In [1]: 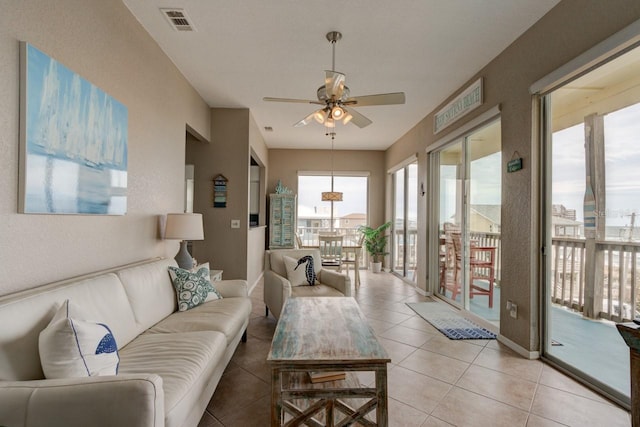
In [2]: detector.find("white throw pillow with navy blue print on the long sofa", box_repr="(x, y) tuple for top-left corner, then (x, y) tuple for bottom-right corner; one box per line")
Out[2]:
(39, 300), (120, 378)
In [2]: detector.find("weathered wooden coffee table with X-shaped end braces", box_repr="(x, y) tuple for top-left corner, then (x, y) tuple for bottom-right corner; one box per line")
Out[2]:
(267, 297), (391, 427)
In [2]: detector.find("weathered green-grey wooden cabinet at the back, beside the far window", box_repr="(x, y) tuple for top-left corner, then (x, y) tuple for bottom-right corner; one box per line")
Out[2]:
(269, 194), (296, 249)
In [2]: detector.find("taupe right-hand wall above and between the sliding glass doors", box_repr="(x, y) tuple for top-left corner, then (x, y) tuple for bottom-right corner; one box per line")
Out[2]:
(386, 0), (640, 351)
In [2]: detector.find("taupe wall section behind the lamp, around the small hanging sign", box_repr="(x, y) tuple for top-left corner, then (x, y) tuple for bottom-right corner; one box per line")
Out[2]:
(187, 108), (268, 285)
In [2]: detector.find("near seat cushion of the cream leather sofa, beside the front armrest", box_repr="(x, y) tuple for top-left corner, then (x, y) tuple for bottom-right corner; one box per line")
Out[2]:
(120, 332), (227, 425)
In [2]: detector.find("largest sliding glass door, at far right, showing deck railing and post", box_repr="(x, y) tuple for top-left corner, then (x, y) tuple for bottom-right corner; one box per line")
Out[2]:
(542, 48), (640, 403)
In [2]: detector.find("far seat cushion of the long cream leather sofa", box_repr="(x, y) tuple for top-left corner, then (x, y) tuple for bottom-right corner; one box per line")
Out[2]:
(147, 298), (251, 343)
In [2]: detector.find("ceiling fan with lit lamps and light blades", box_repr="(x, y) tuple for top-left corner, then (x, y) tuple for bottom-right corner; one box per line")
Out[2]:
(262, 31), (405, 128)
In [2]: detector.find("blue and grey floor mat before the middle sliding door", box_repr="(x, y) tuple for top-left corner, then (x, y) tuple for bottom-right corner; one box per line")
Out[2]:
(406, 302), (496, 340)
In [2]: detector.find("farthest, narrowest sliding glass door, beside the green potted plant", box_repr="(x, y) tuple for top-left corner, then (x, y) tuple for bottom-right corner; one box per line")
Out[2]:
(391, 162), (418, 282)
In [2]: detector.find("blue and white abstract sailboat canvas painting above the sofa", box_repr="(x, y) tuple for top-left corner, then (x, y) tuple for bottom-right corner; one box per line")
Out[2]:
(19, 42), (128, 215)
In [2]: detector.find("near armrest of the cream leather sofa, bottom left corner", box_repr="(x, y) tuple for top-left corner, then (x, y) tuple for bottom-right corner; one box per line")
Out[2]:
(0, 374), (164, 427)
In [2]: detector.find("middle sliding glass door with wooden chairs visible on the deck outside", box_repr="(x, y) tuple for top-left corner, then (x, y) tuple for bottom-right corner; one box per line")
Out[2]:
(430, 120), (502, 326)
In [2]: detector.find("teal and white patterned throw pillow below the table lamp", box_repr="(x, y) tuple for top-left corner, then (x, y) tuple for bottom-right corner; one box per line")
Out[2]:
(169, 267), (222, 311)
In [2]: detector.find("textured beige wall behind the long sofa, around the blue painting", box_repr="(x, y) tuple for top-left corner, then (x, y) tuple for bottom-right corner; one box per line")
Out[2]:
(0, 0), (210, 294)
